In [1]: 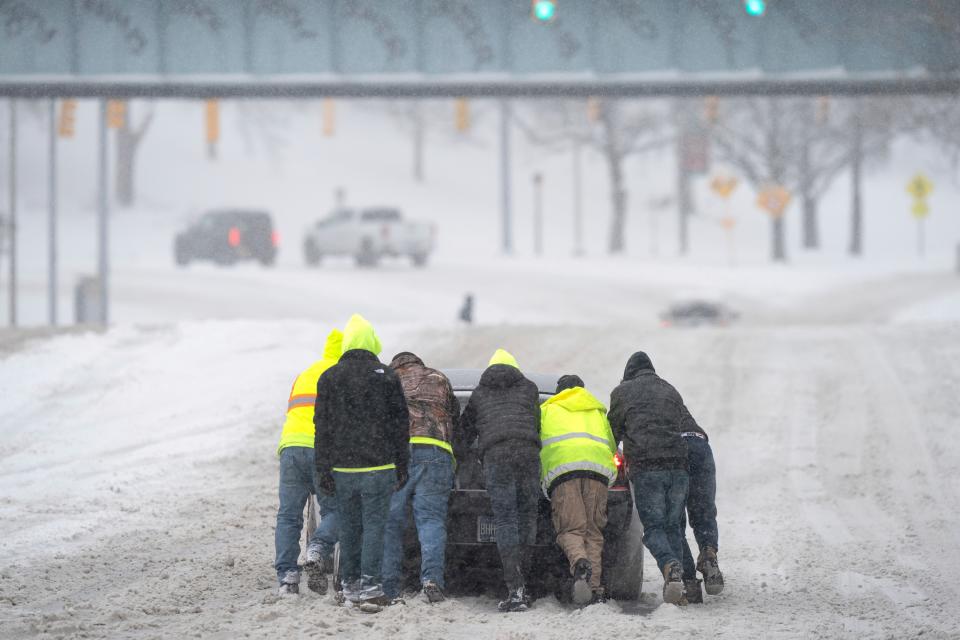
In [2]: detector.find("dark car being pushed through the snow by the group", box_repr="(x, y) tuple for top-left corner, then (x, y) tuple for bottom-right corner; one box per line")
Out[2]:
(382, 369), (643, 600)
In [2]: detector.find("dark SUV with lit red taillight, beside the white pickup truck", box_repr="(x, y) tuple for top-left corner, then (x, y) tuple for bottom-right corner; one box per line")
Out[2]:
(173, 209), (279, 266)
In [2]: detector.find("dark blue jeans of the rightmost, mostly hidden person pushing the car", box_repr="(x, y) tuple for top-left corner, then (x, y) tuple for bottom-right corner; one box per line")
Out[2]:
(683, 436), (720, 580)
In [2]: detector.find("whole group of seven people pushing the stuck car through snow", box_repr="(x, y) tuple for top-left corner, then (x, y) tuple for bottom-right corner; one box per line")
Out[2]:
(275, 315), (723, 612)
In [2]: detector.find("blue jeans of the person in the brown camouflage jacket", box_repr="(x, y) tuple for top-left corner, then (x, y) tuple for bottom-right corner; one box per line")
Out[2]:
(383, 445), (453, 598)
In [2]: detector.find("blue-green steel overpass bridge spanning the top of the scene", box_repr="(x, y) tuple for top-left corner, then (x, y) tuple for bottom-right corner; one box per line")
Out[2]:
(0, 0), (960, 98)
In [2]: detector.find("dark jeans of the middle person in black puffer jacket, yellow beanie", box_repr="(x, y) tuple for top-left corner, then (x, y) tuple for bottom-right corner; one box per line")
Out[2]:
(483, 449), (542, 591)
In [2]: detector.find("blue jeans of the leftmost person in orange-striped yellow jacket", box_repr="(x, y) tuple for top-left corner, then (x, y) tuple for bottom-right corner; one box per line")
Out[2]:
(274, 447), (338, 580)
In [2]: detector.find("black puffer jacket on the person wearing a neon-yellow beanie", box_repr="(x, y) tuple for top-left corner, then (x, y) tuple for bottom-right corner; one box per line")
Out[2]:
(460, 364), (540, 462)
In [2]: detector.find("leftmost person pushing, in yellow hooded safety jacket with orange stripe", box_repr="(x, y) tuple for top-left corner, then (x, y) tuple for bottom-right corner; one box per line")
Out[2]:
(276, 329), (343, 595)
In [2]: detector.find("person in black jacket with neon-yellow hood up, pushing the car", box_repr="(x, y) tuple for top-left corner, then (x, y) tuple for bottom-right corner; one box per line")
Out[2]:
(314, 315), (409, 605)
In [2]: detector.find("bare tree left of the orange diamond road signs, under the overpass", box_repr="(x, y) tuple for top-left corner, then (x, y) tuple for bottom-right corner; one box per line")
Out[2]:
(514, 99), (674, 254)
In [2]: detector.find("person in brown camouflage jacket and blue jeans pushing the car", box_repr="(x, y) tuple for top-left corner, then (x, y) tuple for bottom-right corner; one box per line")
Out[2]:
(383, 351), (460, 602)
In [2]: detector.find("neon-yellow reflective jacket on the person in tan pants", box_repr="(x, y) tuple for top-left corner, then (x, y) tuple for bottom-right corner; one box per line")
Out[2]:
(540, 387), (617, 497)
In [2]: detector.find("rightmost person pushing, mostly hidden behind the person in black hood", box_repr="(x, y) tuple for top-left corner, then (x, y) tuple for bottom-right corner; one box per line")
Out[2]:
(680, 405), (723, 604)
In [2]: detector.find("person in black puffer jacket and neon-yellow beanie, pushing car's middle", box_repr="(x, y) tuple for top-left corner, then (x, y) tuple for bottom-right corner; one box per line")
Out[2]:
(460, 349), (540, 611)
